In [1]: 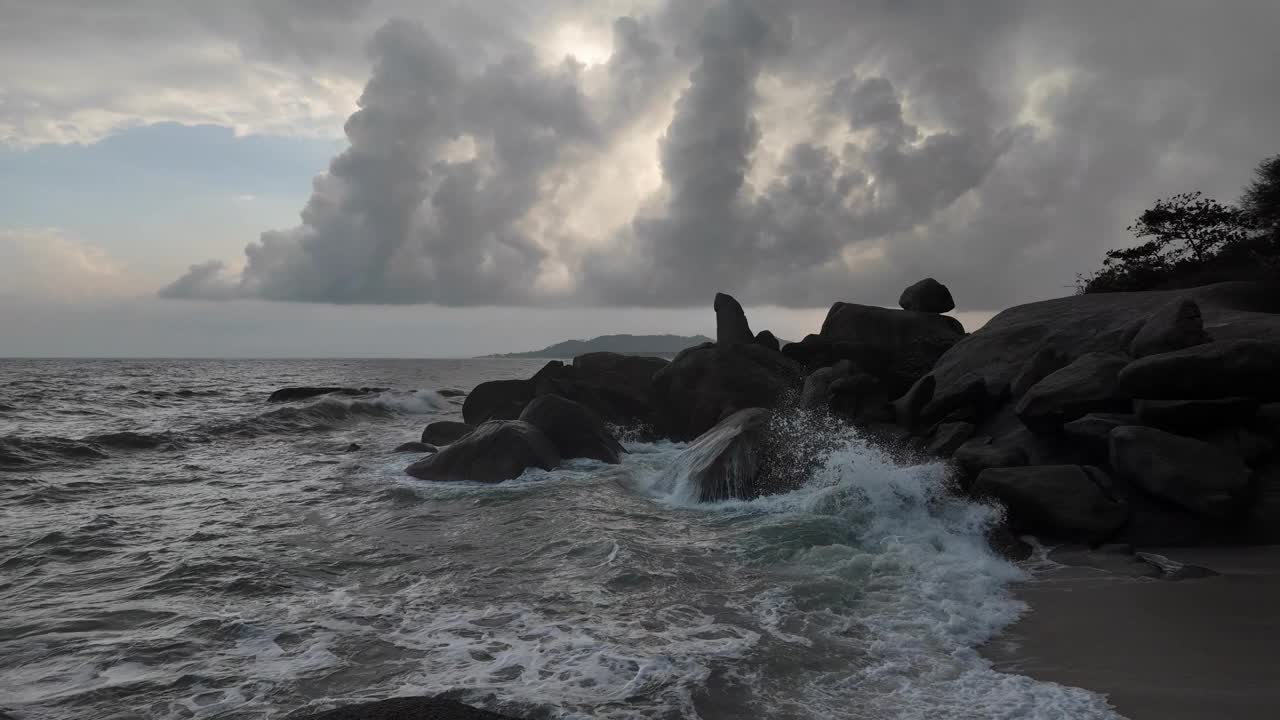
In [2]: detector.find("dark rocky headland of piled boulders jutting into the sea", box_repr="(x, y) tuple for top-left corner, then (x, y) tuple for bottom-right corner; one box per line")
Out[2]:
(285, 278), (1280, 719)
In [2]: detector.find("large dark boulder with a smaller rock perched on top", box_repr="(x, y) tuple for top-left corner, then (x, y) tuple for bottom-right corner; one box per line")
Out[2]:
(819, 302), (964, 396)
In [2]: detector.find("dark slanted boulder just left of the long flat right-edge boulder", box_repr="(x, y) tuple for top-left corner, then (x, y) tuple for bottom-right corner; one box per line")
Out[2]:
(1015, 352), (1129, 432)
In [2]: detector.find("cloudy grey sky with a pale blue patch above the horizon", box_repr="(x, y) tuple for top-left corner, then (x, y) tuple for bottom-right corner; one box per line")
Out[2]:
(0, 0), (1280, 357)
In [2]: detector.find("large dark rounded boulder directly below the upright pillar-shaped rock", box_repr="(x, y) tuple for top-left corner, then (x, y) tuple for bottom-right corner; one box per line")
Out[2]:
(653, 343), (800, 439)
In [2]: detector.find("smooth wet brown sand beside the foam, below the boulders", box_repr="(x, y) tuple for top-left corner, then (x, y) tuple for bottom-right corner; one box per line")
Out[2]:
(983, 547), (1280, 720)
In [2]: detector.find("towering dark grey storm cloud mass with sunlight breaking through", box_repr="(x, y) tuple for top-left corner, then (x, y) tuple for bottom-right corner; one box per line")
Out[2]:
(140, 0), (1280, 310)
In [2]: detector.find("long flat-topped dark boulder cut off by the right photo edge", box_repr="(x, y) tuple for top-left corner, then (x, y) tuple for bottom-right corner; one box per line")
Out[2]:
(1119, 340), (1280, 400)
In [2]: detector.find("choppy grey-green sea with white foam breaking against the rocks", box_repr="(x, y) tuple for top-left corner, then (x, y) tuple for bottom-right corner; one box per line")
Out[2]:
(0, 359), (1115, 720)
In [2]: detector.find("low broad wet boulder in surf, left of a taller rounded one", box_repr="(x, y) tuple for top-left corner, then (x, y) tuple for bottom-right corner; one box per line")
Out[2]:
(404, 420), (559, 483)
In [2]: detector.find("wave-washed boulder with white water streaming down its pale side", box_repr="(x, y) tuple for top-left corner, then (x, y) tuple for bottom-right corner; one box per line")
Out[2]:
(664, 407), (785, 502)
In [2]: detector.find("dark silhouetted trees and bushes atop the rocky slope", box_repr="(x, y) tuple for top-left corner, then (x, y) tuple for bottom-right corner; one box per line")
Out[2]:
(1078, 155), (1280, 293)
